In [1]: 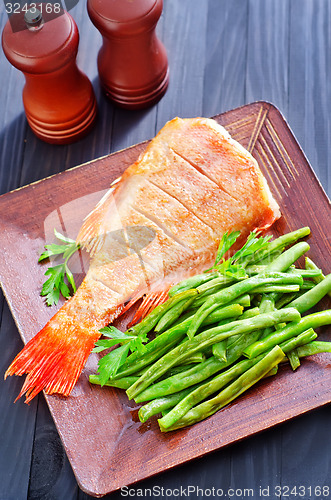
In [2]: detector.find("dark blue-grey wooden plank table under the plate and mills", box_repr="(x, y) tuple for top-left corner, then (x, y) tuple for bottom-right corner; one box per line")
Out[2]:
(0, 0), (331, 500)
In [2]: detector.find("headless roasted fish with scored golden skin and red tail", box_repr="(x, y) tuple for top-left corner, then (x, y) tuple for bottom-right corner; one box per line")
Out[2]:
(5, 118), (280, 402)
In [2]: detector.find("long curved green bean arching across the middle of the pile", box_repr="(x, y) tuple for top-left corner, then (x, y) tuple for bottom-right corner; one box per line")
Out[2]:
(126, 308), (300, 399)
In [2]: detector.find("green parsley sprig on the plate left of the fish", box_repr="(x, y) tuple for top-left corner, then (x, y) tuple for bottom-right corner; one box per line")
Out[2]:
(38, 229), (79, 306)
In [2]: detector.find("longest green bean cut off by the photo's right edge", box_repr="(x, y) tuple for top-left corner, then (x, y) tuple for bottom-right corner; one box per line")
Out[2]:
(244, 309), (331, 358)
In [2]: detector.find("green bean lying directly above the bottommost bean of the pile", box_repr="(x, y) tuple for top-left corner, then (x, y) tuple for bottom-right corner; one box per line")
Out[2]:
(158, 356), (269, 431)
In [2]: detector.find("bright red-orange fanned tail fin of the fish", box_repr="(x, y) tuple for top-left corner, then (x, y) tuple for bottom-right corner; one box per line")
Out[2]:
(5, 318), (100, 403)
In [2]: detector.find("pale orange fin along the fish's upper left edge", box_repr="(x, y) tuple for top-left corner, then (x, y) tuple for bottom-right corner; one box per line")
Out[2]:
(76, 177), (121, 255)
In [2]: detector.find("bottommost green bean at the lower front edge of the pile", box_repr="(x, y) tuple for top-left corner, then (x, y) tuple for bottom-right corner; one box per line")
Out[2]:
(160, 346), (284, 431)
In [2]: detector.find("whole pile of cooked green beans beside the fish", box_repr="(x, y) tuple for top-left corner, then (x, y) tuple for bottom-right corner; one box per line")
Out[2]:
(90, 227), (331, 432)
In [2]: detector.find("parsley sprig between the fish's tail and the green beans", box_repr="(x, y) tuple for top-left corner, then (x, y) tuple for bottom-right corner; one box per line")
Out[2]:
(93, 326), (148, 385)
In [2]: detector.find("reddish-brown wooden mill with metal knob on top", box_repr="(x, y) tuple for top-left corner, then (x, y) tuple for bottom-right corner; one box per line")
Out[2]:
(2, 8), (97, 144)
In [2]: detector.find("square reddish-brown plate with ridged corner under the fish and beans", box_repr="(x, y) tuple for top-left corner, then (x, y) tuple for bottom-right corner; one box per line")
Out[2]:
(0, 102), (331, 496)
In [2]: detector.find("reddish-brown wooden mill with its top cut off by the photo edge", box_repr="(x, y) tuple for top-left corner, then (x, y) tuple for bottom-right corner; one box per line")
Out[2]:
(87, 0), (169, 109)
